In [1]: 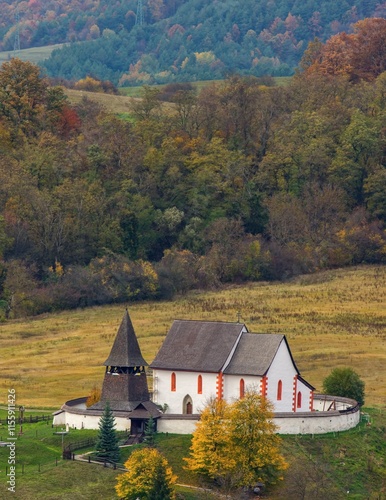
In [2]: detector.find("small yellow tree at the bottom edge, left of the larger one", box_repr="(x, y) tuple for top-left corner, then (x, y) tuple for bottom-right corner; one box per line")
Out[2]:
(115, 448), (177, 500)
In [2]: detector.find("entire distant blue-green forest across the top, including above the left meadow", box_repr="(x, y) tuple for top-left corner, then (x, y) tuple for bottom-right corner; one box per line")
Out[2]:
(0, 0), (386, 86)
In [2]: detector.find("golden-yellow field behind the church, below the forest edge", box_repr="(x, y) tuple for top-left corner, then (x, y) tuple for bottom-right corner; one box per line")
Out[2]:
(0, 266), (386, 408)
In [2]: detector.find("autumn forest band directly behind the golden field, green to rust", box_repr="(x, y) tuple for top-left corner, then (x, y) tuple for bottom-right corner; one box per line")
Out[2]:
(0, 19), (386, 318)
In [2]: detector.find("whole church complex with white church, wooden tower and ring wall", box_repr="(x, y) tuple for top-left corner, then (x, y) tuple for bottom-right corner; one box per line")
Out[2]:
(54, 310), (360, 434)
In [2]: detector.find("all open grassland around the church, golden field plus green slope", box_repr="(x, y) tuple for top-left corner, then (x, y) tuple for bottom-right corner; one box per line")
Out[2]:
(0, 266), (386, 500)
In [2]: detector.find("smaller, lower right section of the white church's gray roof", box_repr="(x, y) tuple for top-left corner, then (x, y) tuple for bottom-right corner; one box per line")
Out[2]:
(224, 333), (284, 375)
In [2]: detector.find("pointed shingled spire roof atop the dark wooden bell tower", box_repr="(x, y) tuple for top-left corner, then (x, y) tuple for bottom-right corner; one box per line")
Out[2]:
(103, 309), (148, 367)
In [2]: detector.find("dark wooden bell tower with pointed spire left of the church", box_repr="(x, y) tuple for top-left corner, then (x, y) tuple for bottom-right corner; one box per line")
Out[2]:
(93, 309), (149, 411)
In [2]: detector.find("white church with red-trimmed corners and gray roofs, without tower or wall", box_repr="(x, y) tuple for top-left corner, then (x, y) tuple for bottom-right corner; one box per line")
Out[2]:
(150, 320), (314, 415)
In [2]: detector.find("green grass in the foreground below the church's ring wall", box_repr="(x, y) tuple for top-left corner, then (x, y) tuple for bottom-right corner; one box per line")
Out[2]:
(0, 410), (386, 500)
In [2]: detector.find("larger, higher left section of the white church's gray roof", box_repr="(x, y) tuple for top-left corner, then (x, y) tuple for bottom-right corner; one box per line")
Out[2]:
(150, 320), (245, 373)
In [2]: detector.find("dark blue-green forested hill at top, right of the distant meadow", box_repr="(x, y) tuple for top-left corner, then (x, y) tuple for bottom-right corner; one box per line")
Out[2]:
(44, 0), (385, 85)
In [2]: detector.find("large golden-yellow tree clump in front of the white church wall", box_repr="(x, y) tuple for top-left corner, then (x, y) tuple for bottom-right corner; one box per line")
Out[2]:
(185, 390), (287, 491)
